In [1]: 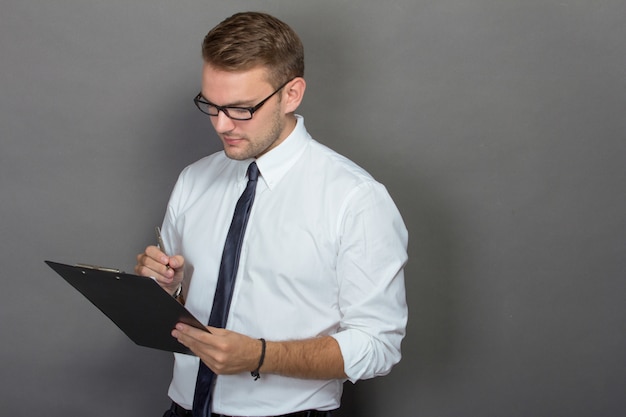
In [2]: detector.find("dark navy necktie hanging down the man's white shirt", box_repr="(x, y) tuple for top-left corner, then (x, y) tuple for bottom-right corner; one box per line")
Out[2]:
(193, 162), (259, 417)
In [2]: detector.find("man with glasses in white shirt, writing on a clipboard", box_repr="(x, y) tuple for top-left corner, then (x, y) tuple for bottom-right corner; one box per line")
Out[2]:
(135, 13), (407, 416)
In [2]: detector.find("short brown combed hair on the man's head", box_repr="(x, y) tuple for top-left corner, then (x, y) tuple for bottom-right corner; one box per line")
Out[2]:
(202, 12), (304, 88)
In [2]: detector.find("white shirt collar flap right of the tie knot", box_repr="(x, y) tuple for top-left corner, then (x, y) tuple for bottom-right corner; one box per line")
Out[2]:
(254, 115), (311, 190)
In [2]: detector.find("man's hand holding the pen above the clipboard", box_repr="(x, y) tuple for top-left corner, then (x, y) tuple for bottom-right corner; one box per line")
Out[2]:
(135, 246), (185, 294)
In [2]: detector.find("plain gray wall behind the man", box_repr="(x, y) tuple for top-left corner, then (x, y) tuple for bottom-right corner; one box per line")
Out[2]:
(0, 0), (626, 417)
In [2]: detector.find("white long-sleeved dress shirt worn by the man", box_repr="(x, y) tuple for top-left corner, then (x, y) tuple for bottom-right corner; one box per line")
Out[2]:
(162, 116), (407, 416)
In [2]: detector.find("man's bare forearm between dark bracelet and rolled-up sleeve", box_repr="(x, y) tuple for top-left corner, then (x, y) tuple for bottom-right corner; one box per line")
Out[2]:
(260, 336), (346, 379)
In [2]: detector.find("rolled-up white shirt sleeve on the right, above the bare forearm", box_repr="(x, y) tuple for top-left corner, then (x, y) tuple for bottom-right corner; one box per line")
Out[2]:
(333, 182), (408, 382)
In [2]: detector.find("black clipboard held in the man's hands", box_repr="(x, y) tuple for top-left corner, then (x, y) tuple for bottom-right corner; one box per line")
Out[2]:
(45, 261), (207, 355)
